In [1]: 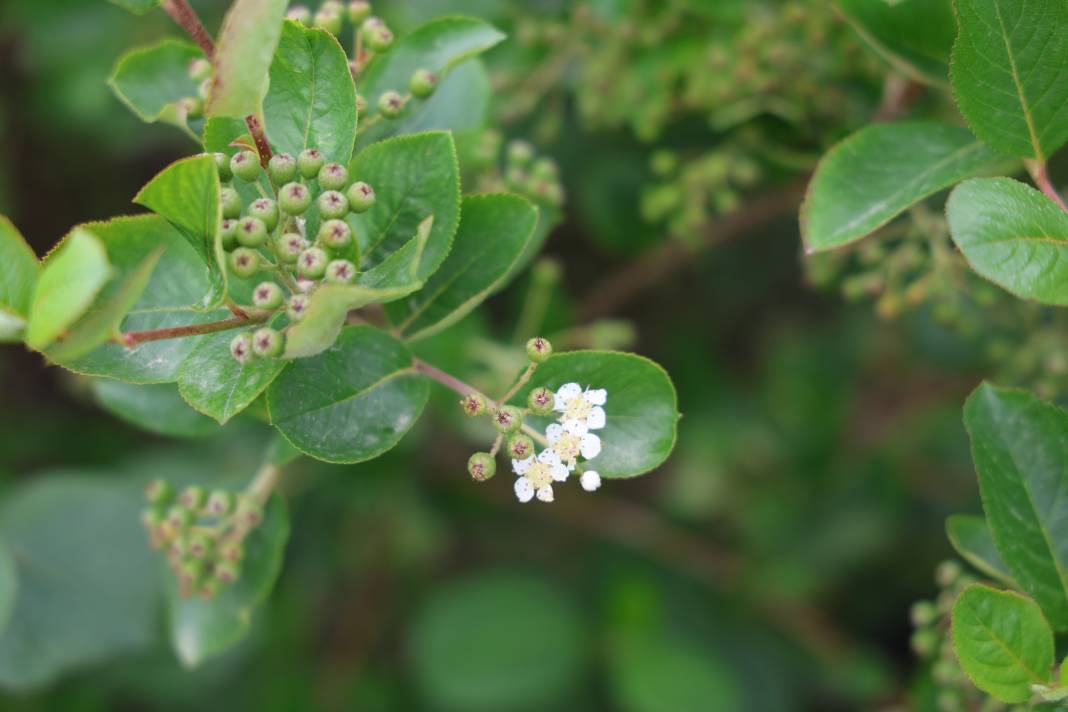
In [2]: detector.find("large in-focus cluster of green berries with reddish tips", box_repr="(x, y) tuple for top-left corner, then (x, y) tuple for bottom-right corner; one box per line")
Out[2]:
(215, 148), (375, 363)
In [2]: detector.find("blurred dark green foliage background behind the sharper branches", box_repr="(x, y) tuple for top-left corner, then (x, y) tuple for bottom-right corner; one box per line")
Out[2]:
(0, 0), (1029, 710)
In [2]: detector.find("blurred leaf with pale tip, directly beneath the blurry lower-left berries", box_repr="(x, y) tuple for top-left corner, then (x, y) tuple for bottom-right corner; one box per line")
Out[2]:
(164, 494), (289, 667)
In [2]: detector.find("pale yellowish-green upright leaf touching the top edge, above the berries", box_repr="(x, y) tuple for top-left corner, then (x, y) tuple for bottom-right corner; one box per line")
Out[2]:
(204, 0), (287, 118)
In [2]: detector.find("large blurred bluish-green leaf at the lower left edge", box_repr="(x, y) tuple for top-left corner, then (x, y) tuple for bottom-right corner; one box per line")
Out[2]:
(0, 472), (158, 690)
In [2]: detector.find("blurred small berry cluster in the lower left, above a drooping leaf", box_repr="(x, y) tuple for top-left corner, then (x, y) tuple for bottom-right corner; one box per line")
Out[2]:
(141, 479), (263, 598)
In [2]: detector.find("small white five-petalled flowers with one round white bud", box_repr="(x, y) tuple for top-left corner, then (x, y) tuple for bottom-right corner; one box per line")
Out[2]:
(512, 383), (608, 502)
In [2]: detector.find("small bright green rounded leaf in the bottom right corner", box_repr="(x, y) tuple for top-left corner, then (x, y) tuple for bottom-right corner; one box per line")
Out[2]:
(952, 584), (1053, 702)
